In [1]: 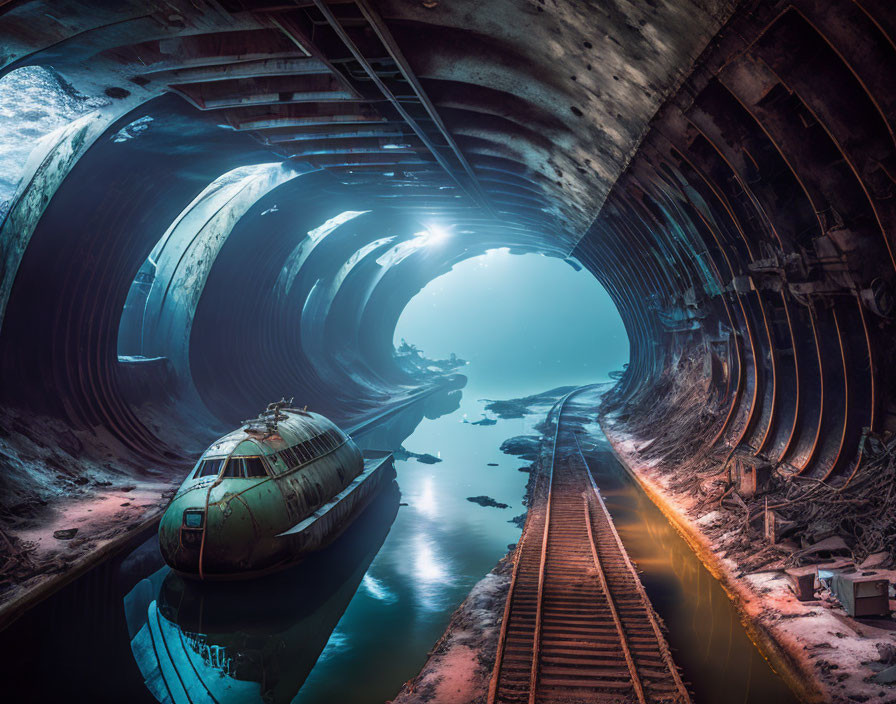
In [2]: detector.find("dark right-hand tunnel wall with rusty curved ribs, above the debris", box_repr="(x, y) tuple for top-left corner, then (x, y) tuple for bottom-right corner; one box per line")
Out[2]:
(578, 2), (896, 486)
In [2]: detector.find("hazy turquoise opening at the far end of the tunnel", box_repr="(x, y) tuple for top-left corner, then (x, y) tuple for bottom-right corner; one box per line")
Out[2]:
(395, 249), (629, 397)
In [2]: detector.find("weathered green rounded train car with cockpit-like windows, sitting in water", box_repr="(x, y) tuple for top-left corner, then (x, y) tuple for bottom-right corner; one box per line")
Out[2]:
(159, 401), (395, 579)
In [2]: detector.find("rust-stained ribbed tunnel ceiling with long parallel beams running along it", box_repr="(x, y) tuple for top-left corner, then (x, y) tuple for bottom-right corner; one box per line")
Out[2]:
(0, 0), (733, 249)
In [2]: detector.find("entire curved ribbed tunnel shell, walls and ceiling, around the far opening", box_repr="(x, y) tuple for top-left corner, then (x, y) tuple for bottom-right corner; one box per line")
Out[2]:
(0, 0), (896, 676)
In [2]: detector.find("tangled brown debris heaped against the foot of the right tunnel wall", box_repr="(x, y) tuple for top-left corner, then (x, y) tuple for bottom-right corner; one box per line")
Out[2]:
(601, 351), (896, 571)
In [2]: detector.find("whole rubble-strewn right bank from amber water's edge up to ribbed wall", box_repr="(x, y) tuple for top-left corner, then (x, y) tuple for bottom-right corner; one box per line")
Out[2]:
(601, 350), (896, 704)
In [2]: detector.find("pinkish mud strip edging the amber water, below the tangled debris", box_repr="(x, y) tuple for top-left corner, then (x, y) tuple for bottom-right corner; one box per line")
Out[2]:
(602, 415), (896, 704)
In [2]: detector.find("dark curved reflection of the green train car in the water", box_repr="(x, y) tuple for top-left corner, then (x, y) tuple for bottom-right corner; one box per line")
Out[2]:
(124, 482), (399, 704)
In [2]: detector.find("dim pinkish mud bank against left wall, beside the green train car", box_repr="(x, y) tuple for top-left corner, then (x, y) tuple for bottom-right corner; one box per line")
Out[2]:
(0, 409), (186, 629)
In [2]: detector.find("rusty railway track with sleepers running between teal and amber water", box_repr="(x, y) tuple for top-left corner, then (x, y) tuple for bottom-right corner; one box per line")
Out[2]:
(488, 387), (691, 704)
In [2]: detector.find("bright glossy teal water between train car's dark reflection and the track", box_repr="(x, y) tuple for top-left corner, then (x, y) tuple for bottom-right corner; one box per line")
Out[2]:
(294, 387), (547, 704)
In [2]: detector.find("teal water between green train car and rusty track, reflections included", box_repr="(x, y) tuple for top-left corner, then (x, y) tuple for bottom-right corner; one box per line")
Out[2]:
(114, 389), (546, 704)
